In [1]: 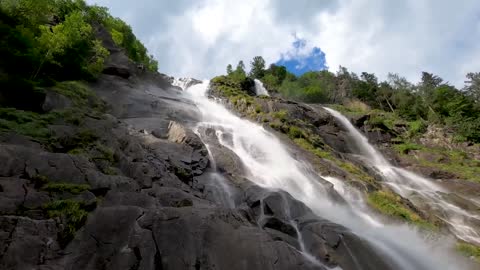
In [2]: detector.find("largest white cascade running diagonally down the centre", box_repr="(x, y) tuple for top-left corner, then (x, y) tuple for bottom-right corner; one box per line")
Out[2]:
(182, 81), (470, 270)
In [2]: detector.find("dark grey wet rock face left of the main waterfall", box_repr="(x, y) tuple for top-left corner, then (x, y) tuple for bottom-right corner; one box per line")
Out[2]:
(0, 61), (404, 269)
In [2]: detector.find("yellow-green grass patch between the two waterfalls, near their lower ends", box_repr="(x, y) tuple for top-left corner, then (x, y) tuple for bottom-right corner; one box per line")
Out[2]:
(367, 190), (435, 229)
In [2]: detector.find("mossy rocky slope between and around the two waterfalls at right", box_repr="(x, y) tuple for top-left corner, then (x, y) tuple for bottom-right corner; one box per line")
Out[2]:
(211, 76), (480, 258)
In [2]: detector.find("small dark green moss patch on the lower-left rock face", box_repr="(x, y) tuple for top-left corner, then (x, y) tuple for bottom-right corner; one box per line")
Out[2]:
(43, 200), (93, 245)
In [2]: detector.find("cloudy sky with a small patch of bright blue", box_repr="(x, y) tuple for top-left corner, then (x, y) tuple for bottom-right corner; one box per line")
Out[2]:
(87, 0), (480, 86)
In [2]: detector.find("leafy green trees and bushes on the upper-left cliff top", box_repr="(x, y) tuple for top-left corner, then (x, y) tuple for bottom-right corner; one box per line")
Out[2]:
(0, 0), (157, 111)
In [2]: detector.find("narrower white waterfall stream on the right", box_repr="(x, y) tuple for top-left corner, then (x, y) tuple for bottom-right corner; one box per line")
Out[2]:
(325, 108), (480, 247)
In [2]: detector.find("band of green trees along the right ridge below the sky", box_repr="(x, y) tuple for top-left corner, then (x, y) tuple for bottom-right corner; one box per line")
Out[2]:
(223, 56), (480, 143)
